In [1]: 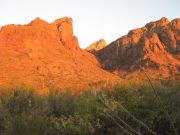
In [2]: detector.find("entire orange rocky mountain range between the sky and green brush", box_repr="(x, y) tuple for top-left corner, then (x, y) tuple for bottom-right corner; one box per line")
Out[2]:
(0, 17), (180, 93)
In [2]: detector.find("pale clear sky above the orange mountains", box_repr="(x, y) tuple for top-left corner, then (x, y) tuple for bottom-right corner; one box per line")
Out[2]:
(0, 0), (180, 48)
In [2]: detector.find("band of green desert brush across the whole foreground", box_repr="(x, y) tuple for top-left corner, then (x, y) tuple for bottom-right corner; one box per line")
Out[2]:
(0, 85), (180, 135)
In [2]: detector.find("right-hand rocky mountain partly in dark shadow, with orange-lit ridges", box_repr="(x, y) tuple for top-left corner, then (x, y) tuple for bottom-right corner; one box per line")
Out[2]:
(93, 17), (180, 79)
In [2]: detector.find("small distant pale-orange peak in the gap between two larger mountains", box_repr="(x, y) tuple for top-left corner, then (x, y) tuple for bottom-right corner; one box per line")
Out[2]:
(85, 39), (107, 53)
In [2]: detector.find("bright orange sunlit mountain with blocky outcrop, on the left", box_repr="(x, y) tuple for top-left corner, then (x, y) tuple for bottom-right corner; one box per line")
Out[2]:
(0, 17), (119, 93)
